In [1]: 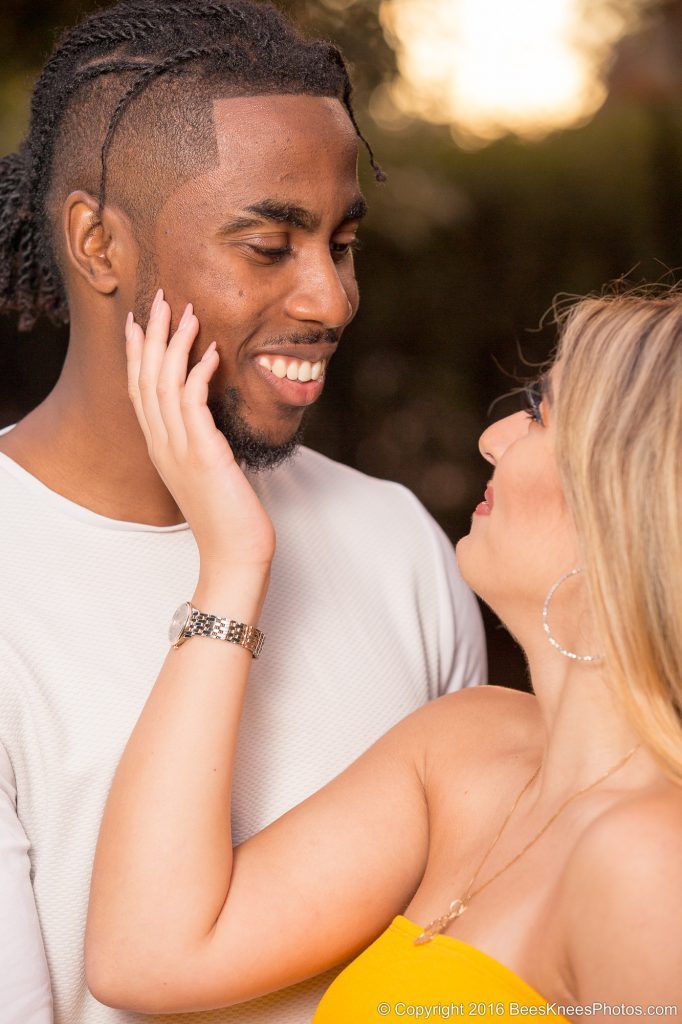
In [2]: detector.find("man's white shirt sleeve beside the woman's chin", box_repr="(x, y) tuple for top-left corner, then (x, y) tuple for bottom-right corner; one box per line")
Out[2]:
(401, 492), (487, 696)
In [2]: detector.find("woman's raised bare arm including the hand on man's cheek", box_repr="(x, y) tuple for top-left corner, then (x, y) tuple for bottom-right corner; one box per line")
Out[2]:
(86, 302), (430, 1013)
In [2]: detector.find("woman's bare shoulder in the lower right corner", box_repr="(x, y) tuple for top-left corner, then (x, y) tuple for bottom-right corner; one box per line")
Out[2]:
(561, 782), (682, 1004)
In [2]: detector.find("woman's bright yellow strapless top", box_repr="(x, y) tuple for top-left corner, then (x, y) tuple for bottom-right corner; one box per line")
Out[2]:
(312, 916), (565, 1024)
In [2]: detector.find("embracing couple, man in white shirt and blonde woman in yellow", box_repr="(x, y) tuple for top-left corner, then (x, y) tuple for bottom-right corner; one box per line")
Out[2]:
(0, 0), (682, 1024)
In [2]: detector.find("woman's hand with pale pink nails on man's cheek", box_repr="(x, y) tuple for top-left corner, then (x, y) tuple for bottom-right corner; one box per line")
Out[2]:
(126, 289), (274, 571)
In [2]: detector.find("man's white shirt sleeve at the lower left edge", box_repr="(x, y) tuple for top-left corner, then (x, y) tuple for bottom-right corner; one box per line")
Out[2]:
(0, 744), (52, 1024)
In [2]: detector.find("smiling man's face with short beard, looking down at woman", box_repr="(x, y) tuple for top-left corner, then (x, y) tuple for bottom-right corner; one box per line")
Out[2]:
(146, 95), (365, 468)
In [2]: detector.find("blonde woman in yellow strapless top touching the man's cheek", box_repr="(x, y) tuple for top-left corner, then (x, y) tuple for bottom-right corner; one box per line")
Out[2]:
(86, 295), (682, 1024)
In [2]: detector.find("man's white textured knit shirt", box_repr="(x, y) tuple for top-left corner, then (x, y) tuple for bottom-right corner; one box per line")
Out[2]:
(0, 440), (485, 1024)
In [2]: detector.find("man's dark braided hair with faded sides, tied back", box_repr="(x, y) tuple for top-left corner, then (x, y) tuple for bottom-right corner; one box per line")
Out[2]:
(0, 0), (384, 330)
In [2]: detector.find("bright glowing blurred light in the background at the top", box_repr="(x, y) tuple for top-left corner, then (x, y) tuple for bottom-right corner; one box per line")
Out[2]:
(371, 0), (649, 145)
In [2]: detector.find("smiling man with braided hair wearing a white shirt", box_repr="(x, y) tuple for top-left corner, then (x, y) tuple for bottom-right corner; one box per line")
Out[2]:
(0, 0), (484, 1024)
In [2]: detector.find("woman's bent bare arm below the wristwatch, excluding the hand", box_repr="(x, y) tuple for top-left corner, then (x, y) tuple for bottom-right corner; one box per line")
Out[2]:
(86, 639), (430, 1013)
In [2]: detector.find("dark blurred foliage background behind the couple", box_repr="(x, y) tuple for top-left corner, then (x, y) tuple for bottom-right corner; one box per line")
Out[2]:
(0, 0), (682, 685)
